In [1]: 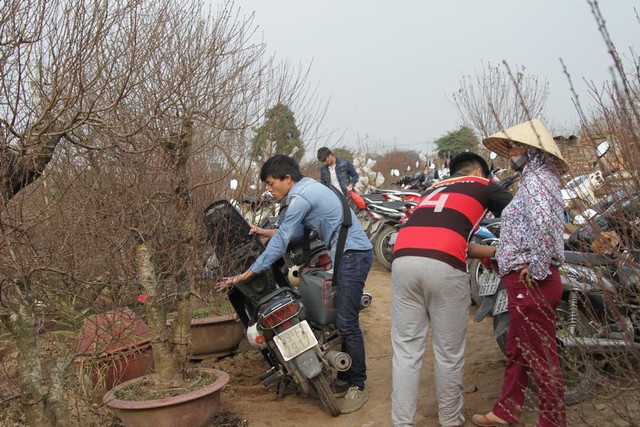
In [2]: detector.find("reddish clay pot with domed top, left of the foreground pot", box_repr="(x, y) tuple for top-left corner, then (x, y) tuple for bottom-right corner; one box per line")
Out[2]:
(74, 308), (153, 401)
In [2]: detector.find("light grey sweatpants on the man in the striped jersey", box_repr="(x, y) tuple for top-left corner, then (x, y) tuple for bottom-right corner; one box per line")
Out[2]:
(391, 256), (470, 427)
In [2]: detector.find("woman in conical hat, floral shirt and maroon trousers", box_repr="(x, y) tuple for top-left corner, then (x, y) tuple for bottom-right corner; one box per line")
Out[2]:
(472, 119), (569, 427)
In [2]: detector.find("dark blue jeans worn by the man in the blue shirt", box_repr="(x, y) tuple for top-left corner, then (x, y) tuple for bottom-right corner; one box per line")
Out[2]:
(336, 250), (373, 390)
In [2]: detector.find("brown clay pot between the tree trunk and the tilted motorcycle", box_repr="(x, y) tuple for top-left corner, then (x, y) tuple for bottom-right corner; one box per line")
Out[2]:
(189, 316), (244, 360)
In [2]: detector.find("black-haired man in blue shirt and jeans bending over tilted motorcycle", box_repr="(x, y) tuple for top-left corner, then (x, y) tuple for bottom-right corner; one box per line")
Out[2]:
(216, 154), (373, 414)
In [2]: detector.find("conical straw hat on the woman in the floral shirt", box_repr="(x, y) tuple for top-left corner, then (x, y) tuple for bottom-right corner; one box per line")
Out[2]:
(482, 119), (569, 174)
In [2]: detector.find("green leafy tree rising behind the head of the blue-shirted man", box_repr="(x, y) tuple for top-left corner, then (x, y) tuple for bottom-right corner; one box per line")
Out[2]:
(253, 104), (304, 162)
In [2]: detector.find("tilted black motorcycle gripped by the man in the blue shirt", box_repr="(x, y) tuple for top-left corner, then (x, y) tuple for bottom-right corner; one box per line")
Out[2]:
(204, 200), (371, 416)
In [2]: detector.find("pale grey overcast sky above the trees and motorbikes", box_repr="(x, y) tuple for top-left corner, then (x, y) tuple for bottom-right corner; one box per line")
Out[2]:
(225, 0), (640, 155)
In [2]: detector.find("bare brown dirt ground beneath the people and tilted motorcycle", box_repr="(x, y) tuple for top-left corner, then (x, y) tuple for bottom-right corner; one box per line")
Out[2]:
(0, 263), (640, 427)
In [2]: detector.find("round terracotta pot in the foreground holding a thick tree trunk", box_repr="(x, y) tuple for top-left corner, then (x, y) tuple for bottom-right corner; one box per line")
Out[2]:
(103, 368), (229, 427)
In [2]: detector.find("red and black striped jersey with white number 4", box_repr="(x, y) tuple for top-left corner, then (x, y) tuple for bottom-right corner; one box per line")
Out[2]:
(393, 176), (508, 271)
